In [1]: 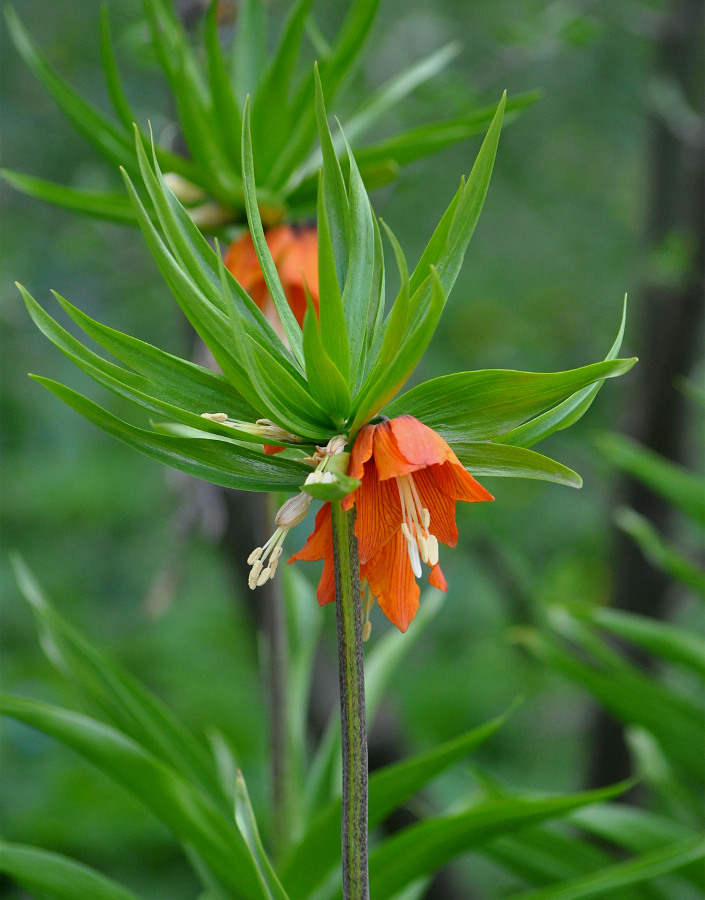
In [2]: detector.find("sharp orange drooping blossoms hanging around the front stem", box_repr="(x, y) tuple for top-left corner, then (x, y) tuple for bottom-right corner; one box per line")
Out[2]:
(289, 416), (494, 631)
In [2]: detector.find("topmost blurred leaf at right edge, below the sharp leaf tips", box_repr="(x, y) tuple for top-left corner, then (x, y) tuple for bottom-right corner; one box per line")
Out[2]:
(598, 434), (705, 527)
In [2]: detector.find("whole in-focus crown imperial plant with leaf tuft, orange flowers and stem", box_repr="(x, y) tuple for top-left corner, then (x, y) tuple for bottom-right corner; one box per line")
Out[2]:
(11, 63), (634, 898)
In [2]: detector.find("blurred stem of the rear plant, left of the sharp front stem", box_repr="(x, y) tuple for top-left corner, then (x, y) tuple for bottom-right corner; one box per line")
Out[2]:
(262, 494), (292, 858)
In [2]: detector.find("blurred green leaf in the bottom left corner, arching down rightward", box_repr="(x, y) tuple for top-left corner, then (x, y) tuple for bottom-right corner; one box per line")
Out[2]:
(0, 840), (144, 900)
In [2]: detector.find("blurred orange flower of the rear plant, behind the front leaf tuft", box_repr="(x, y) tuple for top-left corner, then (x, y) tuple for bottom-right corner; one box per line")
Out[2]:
(223, 225), (318, 325)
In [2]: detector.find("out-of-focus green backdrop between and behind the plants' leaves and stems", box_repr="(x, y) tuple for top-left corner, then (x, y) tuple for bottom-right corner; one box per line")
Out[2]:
(0, 0), (702, 898)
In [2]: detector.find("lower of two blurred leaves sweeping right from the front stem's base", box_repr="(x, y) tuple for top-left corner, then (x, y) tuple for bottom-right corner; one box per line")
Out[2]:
(366, 784), (627, 900)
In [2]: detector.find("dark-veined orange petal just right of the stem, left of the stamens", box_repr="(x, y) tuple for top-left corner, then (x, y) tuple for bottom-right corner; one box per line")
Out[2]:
(353, 460), (401, 563)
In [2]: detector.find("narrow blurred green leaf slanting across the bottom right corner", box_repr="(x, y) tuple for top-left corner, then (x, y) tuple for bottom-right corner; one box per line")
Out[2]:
(513, 835), (705, 900)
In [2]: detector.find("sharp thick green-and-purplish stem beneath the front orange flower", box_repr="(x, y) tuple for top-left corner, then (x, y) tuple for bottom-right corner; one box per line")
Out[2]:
(331, 503), (370, 900)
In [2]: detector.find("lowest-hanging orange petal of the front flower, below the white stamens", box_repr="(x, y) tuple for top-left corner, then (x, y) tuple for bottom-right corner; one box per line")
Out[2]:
(361, 532), (421, 631)
